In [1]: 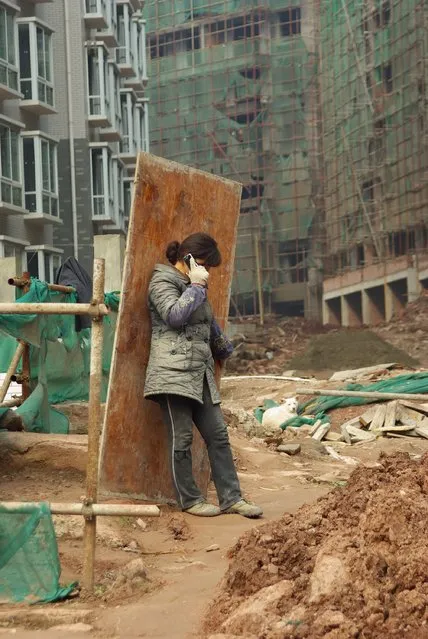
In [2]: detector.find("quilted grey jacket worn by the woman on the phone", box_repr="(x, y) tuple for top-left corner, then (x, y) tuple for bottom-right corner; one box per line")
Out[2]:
(144, 264), (220, 404)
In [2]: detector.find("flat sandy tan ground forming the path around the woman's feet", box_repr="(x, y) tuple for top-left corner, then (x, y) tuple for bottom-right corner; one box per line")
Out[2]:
(0, 380), (428, 639)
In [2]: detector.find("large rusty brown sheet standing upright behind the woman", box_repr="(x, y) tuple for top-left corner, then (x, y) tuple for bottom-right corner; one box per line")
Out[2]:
(100, 153), (241, 502)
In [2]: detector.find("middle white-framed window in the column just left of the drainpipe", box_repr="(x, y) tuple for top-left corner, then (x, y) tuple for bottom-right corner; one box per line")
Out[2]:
(23, 132), (59, 217)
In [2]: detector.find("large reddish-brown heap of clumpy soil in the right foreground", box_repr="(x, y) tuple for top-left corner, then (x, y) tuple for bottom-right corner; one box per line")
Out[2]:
(205, 453), (428, 639)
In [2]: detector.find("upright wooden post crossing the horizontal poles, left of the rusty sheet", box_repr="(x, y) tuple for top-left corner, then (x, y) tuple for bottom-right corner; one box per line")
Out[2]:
(82, 258), (105, 592)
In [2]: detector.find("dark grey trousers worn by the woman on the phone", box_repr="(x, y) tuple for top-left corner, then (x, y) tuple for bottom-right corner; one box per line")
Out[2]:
(158, 381), (241, 510)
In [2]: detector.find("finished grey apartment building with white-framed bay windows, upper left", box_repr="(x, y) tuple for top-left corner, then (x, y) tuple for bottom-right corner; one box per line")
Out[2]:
(0, 0), (149, 281)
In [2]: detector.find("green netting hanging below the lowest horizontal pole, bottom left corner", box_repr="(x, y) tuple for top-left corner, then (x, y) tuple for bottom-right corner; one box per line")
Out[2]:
(0, 503), (77, 603)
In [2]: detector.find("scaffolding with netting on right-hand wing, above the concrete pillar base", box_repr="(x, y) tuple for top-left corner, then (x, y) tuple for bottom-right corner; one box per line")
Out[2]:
(320, 0), (428, 276)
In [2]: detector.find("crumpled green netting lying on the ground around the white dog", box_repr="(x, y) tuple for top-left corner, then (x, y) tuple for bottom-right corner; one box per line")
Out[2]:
(254, 373), (428, 429)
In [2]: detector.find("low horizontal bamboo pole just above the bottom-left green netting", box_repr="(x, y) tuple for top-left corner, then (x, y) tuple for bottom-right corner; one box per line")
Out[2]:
(0, 501), (160, 517)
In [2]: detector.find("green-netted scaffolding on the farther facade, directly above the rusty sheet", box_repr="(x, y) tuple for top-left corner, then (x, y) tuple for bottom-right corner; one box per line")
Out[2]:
(146, 0), (319, 314)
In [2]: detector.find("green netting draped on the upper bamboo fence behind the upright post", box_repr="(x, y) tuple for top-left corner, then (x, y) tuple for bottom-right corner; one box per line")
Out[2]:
(0, 279), (119, 433)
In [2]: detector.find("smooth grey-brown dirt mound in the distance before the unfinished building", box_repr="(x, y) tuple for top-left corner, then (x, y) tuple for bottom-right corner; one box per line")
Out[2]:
(289, 329), (417, 372)
